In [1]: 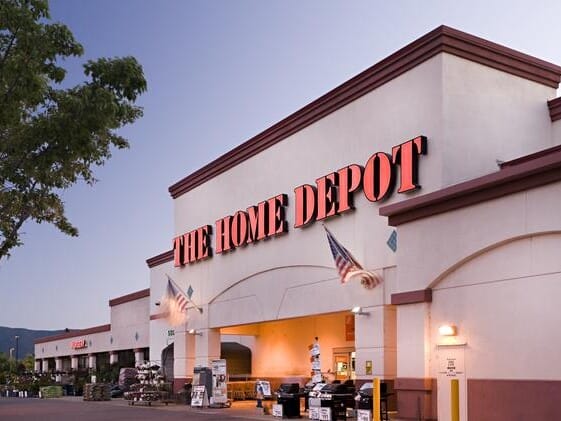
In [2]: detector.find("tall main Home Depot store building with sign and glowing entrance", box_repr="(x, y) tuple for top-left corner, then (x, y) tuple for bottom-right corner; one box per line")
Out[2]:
(38, 27), (561, 420)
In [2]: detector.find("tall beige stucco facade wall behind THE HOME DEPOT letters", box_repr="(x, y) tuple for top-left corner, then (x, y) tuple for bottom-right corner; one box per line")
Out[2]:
(167, 54), (555, 327)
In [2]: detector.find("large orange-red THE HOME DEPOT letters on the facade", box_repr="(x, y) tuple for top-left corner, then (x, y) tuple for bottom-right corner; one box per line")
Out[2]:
(173, 136), (427, 266)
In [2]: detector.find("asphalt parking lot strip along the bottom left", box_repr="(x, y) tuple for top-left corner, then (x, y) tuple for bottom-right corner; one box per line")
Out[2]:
(0, 397), (275, 421)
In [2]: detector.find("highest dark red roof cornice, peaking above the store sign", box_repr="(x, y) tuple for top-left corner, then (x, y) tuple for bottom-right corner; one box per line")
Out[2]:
(169, 26), (561, 199)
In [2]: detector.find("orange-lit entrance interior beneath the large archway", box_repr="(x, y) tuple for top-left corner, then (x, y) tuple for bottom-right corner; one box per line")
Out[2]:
(220, 312), (355, 383)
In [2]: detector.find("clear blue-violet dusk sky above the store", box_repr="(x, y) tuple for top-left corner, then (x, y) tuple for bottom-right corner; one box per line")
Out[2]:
(0, 0), (561, 329)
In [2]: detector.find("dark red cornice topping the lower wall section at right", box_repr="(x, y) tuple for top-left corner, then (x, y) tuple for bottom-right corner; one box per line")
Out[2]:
(379, 148), (561, 226)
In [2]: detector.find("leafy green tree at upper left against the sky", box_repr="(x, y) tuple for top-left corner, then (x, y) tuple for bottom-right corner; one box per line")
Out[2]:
(0, 0), (146, 261)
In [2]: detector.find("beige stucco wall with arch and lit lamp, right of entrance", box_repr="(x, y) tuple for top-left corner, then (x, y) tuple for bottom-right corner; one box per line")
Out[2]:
(397, 183), (561, 380)
